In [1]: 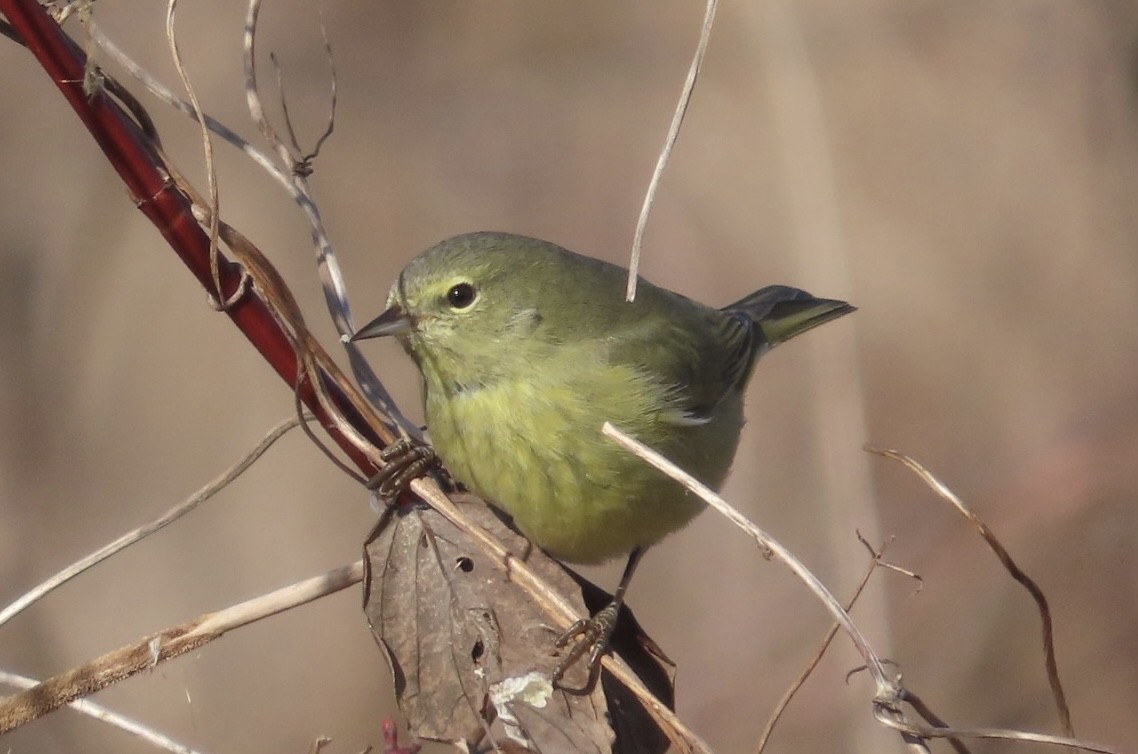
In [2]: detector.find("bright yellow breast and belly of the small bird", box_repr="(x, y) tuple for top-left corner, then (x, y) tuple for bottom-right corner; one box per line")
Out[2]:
(426, 368), (742, 563)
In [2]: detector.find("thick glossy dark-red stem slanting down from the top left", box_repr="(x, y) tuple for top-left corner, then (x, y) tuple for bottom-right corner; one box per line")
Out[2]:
(0, 0), (376, 475)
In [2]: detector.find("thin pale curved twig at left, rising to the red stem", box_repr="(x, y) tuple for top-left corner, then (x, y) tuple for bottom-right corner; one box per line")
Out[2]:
(0, 419), (307, 625)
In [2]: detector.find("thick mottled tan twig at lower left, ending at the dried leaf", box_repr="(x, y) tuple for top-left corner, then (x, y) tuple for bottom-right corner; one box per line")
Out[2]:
(0, 561), (363, 735)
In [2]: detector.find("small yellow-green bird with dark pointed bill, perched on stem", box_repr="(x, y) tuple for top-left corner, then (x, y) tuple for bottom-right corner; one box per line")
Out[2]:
(353, 232), (854, 691)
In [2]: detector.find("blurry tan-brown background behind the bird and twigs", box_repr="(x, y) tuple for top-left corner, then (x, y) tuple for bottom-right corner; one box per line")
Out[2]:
(0, 0), (1138, 753)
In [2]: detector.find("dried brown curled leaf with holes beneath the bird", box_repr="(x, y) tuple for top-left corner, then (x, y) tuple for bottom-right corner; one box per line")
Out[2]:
(364, 504), (671, 754)
